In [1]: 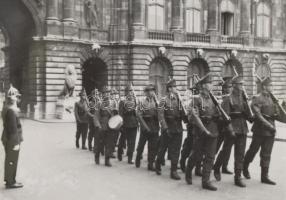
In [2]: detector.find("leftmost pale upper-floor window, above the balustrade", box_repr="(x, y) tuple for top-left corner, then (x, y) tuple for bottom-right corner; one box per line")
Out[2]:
(148, 0), (165, 30)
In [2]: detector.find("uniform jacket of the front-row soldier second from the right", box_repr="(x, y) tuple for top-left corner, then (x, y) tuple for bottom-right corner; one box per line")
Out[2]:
(221, 92), (249, 135)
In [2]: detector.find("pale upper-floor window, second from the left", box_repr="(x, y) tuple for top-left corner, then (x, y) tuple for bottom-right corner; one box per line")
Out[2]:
(185, 0), (201, 33)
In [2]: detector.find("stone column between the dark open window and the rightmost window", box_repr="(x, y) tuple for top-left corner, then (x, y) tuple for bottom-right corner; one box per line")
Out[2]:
(240, 0), (251, 36)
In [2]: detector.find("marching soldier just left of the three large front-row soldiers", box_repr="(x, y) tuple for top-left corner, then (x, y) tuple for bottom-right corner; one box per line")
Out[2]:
(155, 79), (186, 180)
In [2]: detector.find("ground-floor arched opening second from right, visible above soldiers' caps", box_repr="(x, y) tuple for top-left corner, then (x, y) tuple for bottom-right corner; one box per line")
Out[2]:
(222, 59), (243, 77)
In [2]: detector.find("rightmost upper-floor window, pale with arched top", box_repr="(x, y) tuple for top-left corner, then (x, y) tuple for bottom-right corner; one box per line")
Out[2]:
(256, 2), (270, 38)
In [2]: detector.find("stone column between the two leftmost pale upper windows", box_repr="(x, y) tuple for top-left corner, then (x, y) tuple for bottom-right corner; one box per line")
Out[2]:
(171, 0), (182, 30)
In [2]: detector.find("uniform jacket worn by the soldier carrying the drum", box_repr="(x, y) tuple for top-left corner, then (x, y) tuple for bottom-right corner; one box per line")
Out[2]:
(99, 98), (118, 131)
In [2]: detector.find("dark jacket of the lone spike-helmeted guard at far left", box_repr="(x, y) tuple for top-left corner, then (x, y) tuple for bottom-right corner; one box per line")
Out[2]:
(1, 107), (23, 146)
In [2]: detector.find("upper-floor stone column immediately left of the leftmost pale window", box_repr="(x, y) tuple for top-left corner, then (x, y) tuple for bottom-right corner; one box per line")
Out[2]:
(132, 0), (146, 39)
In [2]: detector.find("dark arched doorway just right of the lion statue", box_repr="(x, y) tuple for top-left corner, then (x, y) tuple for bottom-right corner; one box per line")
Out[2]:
(82, 58), (108, 95)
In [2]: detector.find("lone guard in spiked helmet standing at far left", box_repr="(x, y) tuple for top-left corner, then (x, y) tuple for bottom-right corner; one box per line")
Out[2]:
(1, 85), (23, 188)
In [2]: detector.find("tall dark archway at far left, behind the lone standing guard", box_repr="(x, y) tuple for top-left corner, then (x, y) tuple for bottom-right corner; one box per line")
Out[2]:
(0, 0), (36, 92)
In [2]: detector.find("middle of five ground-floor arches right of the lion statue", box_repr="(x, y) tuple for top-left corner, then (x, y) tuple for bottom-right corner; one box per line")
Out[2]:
(187, 58), (210, 88)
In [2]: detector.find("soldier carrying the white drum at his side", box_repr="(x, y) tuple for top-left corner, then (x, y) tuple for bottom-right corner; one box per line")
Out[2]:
(94, 86), (118, 167)
